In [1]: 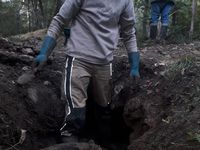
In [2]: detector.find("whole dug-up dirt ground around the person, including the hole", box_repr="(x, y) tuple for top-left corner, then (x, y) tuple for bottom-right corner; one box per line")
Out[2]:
(0, 31), (200, 150)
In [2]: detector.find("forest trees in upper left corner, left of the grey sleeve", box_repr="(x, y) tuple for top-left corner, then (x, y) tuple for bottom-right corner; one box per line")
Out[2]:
(0, 0), (56, 36)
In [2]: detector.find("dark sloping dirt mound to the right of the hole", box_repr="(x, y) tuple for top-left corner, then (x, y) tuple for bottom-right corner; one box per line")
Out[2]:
(126, 66), (200, 150)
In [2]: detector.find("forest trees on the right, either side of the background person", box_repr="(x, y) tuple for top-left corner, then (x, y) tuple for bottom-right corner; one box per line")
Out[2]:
(134, 0), (200, 43)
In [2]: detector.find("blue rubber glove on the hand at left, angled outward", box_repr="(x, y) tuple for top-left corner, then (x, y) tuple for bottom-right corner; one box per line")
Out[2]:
(34, 36), (56, 63)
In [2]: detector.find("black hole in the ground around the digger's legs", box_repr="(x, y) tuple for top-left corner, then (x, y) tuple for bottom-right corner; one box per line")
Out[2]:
(83, 81), (149, 150)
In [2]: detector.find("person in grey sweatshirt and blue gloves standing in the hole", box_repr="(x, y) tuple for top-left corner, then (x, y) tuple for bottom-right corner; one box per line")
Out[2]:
(34, 0), (139, 142)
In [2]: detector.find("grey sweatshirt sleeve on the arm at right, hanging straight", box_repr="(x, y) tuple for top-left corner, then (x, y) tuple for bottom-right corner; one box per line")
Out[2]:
(119, 0), (138, 53)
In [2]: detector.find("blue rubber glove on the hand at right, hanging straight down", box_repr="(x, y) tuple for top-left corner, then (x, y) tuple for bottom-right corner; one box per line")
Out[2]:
(128, 52), (140, 77)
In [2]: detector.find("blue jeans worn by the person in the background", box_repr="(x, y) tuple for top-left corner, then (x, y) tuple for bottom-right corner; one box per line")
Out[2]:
(151, 2), (173, 26)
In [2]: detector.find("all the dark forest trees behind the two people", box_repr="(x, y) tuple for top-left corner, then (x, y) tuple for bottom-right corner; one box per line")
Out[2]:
(0, 0), (200, 43)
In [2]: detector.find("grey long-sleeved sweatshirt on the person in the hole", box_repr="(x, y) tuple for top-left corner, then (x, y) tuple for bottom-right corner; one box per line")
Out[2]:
(47, 0), (137, 64)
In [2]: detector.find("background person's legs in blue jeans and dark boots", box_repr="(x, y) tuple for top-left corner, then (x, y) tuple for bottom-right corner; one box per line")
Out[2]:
(150, 0), (175, 40)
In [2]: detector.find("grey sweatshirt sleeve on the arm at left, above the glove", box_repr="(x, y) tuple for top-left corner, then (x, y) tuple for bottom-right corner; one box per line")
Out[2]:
(47, 0), (82, 39)
